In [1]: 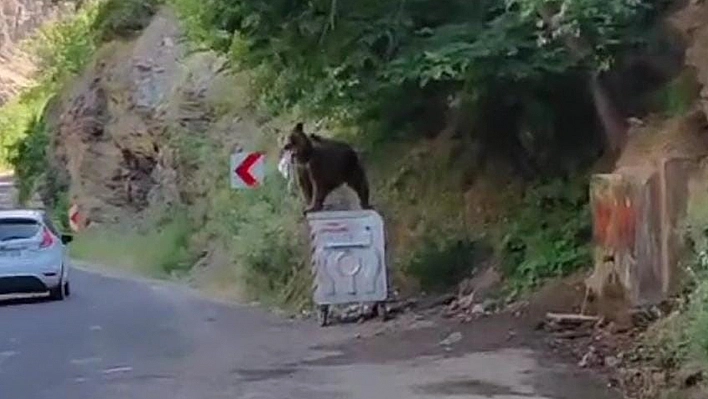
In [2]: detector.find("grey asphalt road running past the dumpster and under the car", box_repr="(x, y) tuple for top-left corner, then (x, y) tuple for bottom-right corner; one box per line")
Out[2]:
(0, 178), (615, 399)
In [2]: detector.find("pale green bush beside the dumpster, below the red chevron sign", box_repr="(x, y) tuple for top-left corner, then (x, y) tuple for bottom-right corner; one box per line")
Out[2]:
(204, 166), (311, 307)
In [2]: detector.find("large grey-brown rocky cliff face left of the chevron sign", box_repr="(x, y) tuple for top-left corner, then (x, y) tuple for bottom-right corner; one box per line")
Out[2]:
(43, 10), (243, 224)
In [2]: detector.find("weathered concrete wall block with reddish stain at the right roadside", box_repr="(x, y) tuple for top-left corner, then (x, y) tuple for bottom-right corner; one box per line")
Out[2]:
(587, 158), (698, 306)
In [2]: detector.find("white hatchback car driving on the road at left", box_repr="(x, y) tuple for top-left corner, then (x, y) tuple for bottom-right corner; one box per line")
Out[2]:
(0, 209), (72, 300)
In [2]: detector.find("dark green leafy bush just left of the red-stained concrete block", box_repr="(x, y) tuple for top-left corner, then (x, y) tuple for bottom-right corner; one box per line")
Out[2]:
(502, 179), (592, 288)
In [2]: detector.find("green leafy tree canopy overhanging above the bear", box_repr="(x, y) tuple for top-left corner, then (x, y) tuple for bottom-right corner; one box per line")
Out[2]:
(172, 0), (651, 134)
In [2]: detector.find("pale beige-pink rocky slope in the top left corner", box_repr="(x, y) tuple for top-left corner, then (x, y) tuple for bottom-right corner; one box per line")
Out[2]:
(0, 0), (69, 104)
